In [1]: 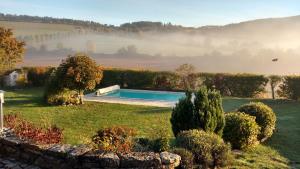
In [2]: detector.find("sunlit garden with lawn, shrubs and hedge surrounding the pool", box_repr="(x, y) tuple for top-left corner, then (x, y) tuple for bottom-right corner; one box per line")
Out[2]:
(0, 29), (300, 169)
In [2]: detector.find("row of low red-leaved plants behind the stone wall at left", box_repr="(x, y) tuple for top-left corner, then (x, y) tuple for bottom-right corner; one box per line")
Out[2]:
(4, 114), (63, 144)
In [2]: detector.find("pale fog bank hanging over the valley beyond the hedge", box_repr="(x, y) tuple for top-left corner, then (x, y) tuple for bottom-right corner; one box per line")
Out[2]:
(4, 17), (300, 74)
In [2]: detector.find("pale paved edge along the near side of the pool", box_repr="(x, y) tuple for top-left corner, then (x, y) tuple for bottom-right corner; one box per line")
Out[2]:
(84, 93), (176, 107)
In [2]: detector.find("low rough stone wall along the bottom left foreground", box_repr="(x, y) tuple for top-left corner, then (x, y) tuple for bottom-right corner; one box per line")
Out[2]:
(0, 129), (180, 169)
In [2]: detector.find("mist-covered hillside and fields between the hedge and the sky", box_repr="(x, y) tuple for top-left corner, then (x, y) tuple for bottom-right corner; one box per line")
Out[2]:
(0, 14), (300, 74)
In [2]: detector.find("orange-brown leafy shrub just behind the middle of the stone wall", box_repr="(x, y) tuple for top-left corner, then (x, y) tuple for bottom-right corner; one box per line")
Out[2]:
(92, 126), (135, 152)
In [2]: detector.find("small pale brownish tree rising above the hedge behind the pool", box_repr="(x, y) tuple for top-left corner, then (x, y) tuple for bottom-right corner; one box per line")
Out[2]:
(175, 64), (199, 90)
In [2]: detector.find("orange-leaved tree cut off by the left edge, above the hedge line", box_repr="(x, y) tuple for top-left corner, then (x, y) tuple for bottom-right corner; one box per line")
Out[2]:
(0, 27), (25, 73)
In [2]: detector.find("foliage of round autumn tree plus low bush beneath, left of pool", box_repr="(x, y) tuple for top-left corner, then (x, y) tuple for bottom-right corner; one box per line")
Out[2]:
(45, 54), (102, 104)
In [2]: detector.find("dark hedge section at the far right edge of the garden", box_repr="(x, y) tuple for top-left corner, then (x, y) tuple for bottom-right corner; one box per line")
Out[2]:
(278, 76), (300, 100)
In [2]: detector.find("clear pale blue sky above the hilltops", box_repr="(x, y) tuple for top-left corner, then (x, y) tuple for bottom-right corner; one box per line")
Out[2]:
(0, 0), (300, 27)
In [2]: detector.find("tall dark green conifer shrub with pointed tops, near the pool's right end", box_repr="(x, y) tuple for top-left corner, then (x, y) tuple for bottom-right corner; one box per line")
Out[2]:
(171, 87), (225, 136)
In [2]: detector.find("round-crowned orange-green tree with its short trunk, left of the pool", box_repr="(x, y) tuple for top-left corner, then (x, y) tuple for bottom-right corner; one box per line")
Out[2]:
(56, 54), (103, 104)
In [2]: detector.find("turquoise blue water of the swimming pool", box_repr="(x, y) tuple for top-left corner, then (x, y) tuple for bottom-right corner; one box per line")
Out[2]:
(105, 89), (185, 102)
